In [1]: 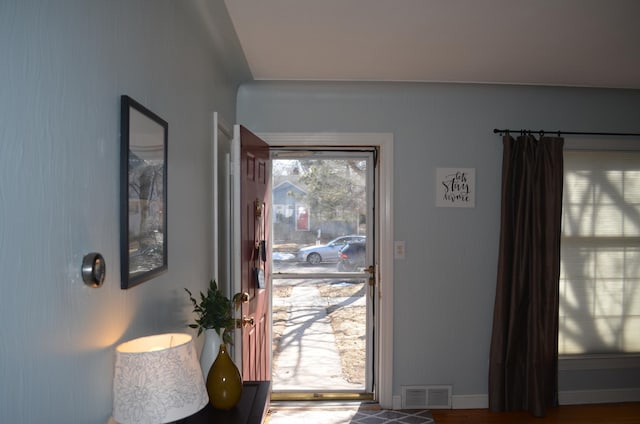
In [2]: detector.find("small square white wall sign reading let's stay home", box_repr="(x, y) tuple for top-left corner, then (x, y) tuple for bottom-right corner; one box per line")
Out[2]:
(436, 168), (476, 208)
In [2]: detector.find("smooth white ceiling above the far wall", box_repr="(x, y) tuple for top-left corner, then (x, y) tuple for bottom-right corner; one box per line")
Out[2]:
(225, 0), (640, 89)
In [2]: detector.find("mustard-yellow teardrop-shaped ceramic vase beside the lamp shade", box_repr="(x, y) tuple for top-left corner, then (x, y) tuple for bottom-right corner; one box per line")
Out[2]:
(207, 343), (242, 409)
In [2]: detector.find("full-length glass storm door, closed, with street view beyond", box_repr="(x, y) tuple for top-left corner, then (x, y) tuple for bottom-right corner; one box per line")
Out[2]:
(270, 150), (377, 400)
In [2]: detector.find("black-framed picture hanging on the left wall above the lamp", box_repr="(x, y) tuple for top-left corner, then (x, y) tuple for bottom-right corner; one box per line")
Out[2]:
(120, 95), (169, 289)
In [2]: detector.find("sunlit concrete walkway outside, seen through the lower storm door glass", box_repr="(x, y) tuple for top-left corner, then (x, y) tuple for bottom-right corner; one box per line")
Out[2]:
(272, 285), (365, 391)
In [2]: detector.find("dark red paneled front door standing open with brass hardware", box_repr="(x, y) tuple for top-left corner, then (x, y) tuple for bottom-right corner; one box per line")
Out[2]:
(234, 125), (271, 381)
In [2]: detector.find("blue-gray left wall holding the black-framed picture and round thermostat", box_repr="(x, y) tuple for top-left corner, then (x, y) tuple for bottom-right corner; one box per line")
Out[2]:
(0, 0), (248, 424)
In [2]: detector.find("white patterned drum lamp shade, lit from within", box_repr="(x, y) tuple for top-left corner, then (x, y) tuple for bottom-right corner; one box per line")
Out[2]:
(113, 333), (209, 424)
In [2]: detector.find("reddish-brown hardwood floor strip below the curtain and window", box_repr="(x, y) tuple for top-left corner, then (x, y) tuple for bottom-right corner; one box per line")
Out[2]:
(431, 402), (640, 424)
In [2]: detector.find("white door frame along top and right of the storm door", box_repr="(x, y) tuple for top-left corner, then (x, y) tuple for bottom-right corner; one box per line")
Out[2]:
(256, 133), (393, 409)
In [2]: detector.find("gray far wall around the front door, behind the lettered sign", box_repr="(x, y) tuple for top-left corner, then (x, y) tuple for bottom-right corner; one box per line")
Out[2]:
(237, 82), (640, 396)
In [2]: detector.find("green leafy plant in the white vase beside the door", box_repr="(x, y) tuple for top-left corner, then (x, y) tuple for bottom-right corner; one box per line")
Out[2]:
(184, 280), (237, 344)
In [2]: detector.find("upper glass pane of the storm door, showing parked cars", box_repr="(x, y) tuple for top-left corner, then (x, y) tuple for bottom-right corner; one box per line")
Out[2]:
(272, 156), (369, 274)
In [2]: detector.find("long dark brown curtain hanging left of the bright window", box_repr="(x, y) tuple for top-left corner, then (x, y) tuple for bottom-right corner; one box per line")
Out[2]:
(489, 134), (564, 417)
